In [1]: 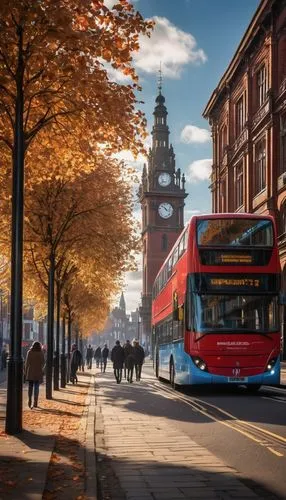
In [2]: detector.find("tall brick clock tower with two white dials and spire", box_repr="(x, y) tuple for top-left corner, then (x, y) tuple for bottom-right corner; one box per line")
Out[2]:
(139, 80), (187, 345)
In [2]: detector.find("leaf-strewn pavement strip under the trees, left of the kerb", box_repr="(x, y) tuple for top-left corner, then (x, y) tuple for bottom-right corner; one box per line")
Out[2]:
(0, 372), (96, 500)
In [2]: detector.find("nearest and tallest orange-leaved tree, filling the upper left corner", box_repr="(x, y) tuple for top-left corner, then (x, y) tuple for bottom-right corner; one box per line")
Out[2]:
(0, 0), (151, 433)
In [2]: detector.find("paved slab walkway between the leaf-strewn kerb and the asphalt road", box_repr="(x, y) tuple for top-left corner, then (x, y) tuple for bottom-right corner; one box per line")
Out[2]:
(96, 372), (274, 500)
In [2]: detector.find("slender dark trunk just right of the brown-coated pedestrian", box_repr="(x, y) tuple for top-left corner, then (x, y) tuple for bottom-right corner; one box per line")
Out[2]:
(46, 254), (55, 399)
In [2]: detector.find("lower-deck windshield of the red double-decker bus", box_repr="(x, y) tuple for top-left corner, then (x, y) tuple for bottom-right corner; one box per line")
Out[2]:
(193, 293), (278, 333)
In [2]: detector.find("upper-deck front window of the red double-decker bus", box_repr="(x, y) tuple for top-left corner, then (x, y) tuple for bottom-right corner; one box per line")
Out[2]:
(197, 218), (273, 247)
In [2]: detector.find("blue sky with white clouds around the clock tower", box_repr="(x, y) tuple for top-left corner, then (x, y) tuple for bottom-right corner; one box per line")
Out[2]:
(105, 0), (260, 312)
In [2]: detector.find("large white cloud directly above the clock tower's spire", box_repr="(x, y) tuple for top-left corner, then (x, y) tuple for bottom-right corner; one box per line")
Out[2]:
(134, 16), (207, 78)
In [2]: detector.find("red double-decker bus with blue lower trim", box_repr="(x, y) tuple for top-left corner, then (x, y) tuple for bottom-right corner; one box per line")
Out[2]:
(152, 213), (281, 390)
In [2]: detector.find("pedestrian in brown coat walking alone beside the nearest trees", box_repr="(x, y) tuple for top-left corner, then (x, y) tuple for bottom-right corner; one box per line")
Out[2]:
(24, 341), (45, 408)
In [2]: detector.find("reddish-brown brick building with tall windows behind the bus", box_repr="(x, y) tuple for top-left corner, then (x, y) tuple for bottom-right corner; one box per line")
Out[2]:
(203, 0), (286, 352)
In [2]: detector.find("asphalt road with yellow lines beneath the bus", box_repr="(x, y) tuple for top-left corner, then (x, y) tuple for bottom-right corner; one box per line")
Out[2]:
(140, 364), (286, 499)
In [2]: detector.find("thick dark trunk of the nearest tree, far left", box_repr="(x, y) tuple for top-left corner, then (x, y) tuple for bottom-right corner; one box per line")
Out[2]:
(6, 25), (25, 434)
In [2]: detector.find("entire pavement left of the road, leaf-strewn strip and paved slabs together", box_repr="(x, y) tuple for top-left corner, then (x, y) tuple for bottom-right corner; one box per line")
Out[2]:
(0, 368), (284, 500)
